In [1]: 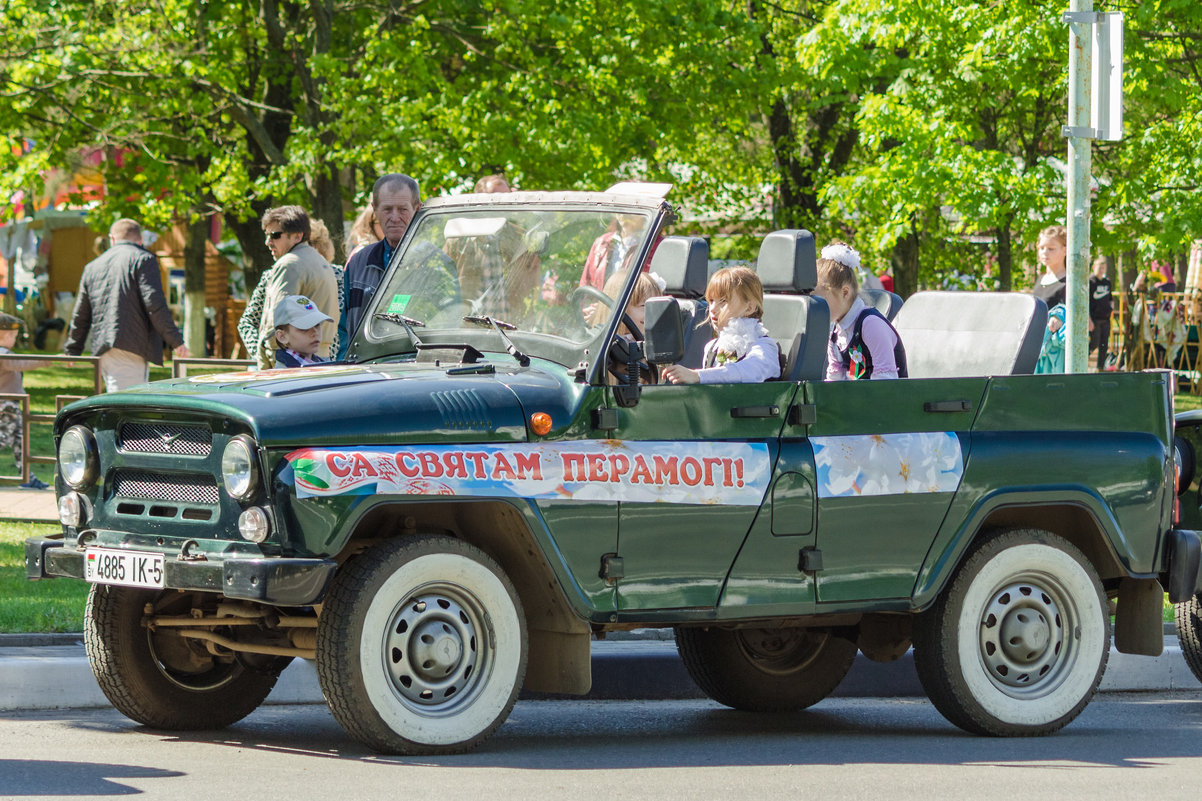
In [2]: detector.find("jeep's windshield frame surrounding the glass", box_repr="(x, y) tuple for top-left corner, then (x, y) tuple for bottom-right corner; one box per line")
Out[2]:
(347, 192), (674, 384)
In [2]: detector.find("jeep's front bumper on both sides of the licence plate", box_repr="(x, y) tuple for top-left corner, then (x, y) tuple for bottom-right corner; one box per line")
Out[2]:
(25, 536), (338, 606)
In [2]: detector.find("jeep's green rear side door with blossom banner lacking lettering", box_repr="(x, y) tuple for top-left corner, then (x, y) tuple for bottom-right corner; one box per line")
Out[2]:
(803, 378), (988, 604)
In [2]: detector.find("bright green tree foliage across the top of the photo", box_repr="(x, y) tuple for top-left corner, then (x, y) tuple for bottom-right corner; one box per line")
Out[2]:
(0, 0), (1202, 293)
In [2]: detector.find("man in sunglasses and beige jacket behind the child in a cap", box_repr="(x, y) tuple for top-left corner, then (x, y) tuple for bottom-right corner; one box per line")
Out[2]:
(238, 206), (338, 369)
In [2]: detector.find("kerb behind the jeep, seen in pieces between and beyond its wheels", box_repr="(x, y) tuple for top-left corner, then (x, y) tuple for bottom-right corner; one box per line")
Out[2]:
(0, 625), (1200, 712)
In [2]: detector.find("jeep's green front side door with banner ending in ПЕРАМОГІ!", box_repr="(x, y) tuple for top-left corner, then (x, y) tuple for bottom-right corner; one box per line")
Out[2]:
(613, 381), (797, 610)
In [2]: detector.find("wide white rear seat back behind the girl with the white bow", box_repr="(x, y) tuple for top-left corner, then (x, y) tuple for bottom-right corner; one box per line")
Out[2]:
(893, 292), (1048, 378)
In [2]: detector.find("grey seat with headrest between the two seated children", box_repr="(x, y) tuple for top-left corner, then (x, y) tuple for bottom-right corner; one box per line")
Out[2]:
(755, 230), (831, 381)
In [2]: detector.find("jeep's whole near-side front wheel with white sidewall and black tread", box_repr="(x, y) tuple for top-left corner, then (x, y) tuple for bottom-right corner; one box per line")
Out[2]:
(317, 536), (526, 754)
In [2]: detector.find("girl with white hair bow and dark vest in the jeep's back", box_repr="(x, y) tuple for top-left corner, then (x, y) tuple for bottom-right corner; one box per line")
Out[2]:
(814, 242), (906, 381)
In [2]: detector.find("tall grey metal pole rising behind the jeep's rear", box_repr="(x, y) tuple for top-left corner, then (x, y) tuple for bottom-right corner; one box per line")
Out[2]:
(1065, 0), (1094, 373)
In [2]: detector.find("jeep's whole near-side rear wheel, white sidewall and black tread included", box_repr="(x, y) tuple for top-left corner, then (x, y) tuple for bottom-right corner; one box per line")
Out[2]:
(914, 529), (1111, 736)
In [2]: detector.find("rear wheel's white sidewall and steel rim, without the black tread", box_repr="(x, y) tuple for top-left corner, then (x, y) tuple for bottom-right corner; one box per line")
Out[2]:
(957, 545), (1106, 725)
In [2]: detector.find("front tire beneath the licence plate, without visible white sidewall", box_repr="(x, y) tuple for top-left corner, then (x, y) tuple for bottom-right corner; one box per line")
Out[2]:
(83, 585), (291, 731)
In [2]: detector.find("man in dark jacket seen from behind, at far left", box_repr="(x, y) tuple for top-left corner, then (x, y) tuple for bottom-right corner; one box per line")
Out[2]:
(63, 219), (188, 392)
